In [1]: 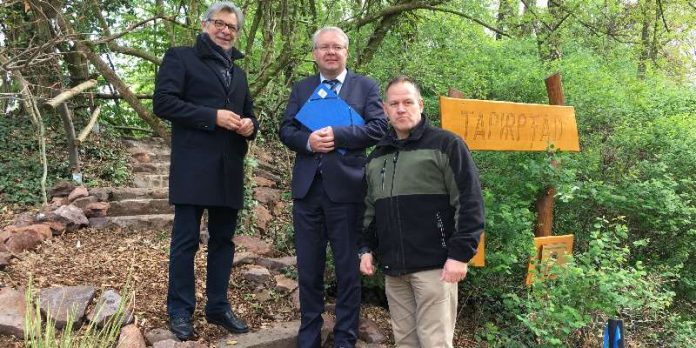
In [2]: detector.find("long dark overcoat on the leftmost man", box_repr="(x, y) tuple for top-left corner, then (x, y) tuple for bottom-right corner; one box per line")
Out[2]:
(153, 36), (258, 209)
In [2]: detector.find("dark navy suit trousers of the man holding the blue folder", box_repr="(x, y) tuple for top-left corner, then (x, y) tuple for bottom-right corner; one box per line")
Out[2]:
(293, 176), (360, 348)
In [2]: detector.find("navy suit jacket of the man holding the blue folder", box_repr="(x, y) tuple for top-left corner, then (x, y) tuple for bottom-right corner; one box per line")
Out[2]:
(280, 71), (387, 203)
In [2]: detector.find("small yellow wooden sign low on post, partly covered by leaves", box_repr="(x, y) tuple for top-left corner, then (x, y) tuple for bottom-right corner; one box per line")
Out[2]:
(526, 234), (575, 285)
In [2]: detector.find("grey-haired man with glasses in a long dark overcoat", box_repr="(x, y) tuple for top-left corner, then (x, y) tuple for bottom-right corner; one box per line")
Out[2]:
(153, 2), (258, 340)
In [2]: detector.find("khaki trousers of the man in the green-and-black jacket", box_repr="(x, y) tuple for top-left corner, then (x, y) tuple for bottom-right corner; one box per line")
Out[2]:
(385, 269), (458, 348)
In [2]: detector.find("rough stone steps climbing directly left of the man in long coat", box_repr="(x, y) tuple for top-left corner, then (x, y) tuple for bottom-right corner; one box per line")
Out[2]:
(90, 138), (174, 229)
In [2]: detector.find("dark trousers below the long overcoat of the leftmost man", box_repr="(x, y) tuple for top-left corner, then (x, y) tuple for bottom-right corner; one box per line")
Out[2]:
(167, 204), (238, 317)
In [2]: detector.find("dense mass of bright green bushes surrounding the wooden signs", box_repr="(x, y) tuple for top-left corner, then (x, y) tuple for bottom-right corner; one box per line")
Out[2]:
(358, 3), (696, 347)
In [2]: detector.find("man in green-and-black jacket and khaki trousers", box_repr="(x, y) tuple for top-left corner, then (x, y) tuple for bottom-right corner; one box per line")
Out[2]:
(358, 76), (484, 347)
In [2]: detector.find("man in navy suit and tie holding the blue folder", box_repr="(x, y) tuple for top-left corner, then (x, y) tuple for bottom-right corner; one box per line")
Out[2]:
(280, 27), (387, 348)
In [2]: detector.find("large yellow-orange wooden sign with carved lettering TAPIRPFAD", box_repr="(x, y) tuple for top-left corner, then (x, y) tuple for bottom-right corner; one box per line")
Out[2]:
(440, 97), (580, 151)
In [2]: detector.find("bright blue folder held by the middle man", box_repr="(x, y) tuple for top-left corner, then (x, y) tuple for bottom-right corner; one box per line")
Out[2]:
(295, 83), (365, 154)
